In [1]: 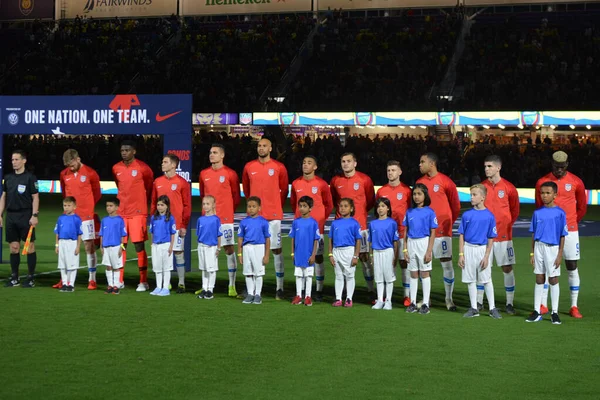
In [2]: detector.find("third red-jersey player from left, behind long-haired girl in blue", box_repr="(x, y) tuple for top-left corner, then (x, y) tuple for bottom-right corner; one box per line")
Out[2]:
(150, 154), (192, 294)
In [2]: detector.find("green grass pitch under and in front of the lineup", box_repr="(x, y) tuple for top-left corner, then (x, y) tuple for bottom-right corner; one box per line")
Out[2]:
(0, 195), (600, 400)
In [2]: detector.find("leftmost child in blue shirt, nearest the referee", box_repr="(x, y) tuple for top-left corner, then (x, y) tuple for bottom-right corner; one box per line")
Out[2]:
(54, 196), (83, 292)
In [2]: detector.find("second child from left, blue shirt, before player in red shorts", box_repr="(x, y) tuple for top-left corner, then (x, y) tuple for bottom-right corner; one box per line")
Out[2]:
(98, 197), (127, 294)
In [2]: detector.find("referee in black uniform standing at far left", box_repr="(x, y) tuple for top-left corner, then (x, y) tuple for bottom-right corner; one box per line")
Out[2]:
(0, 150), (40, 288)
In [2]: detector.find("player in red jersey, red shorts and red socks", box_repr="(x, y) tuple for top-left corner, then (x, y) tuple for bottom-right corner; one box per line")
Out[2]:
(112, 140), (154, 290)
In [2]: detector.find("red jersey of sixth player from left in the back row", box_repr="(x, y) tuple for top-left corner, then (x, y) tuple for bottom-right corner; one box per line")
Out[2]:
(290, 176), (333, 234)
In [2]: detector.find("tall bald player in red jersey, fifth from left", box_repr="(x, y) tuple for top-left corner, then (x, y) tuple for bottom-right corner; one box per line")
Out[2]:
(242, 138), (289, 300)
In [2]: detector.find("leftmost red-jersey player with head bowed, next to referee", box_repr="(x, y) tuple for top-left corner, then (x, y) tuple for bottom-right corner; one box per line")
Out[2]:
(53, 149), (101, 290)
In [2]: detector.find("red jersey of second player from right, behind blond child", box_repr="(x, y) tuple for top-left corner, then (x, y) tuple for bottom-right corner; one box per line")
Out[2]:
(482, 178), (521, 242)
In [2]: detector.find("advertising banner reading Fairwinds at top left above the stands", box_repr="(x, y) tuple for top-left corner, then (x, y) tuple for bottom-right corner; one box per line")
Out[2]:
(61, 0), (177, 18)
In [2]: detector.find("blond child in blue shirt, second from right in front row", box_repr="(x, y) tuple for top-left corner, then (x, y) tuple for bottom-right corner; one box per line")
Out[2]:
(458, 184), (502, 319)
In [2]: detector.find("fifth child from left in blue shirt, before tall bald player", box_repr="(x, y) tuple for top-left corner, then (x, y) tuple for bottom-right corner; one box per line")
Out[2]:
(238, 196), (271, 304)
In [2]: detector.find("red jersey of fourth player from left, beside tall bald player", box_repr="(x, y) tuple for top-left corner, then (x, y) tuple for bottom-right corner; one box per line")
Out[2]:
(199, 165), (241, 224)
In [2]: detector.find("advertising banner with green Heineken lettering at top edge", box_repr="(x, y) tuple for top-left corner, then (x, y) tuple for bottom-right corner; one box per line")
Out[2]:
(181, 0), (312, 16)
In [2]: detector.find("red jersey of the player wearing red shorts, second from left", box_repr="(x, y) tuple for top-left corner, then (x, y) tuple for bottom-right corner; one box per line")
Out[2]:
(113, 160), (154, 217)
